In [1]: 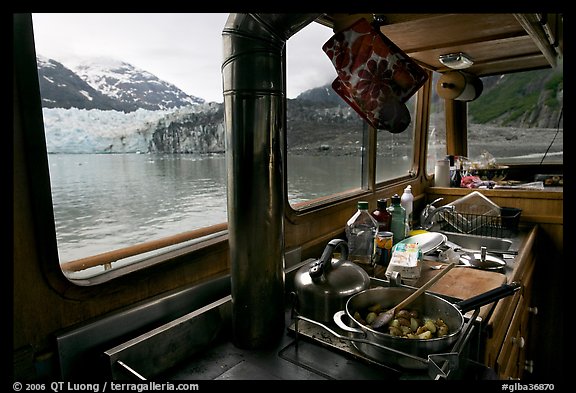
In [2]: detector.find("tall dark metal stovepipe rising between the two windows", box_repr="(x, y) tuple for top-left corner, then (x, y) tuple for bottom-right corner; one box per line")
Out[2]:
(222, 14), (320, 348)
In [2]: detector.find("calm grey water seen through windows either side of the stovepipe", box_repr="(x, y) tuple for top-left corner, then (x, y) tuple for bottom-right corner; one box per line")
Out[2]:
(48, 154), (378, 262)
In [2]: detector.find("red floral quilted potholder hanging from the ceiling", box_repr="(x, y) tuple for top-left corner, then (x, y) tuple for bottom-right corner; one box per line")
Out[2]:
(322, 18), (428, 133)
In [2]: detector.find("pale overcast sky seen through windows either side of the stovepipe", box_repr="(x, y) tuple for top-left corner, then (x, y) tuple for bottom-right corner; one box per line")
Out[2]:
(32, 13), (336, 102)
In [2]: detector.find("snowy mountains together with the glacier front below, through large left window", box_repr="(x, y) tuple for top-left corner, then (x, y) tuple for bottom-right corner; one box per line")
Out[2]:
(37, 56), (224, 153)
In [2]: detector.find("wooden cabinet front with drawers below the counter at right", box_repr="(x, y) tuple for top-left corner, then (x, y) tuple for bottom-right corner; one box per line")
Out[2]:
(484, 227), (537, 379)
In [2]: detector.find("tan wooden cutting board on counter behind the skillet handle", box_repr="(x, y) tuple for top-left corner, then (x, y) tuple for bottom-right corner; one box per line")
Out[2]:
(415, 260), (506, 319)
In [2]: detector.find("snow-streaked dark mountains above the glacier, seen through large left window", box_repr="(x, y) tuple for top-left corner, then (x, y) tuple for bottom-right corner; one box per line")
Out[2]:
(37, 55), (204, 113)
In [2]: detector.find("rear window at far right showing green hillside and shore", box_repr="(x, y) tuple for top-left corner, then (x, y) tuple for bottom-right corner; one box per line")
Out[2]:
(468, 64), (564, 164)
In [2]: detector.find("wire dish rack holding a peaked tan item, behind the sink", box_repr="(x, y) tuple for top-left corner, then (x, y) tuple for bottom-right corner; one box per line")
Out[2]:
(439, 191), (522, 238)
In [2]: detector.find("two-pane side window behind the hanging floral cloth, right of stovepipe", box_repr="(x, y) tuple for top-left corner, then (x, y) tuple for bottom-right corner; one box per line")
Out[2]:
(287, 23), (424, 208)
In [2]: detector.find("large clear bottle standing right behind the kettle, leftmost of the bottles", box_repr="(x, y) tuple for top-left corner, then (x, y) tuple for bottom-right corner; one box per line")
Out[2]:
(346, 201), (378, 274)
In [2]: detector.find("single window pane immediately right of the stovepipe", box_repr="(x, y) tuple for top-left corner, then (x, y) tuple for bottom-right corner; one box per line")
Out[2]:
(286, 23), (367, 207)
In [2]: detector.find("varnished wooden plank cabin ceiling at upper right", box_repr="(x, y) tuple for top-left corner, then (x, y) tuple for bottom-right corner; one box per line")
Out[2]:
(318, 14), (563, 76)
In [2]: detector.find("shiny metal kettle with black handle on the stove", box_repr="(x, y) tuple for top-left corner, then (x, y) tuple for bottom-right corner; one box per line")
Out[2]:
(294, 239), (370, 324)
